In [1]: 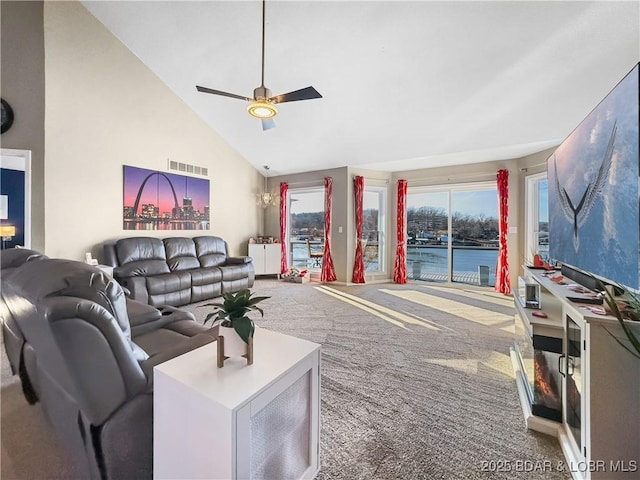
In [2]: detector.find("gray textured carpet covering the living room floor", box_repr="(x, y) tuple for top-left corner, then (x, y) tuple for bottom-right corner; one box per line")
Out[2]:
(1, 279), (571, 480)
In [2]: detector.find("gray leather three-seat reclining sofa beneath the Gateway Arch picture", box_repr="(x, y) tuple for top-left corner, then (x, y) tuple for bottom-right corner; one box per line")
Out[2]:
(104, 236), (255, 306)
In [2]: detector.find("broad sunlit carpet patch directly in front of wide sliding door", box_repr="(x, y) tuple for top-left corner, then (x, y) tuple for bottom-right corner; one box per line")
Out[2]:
(380, 289), (513, 327)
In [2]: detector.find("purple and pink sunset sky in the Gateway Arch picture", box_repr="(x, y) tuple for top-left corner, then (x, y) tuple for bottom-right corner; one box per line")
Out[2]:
(123, 165), (209, 215)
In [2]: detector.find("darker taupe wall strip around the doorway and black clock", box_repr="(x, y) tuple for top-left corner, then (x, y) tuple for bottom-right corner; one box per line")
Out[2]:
(0, 1), (45, 251)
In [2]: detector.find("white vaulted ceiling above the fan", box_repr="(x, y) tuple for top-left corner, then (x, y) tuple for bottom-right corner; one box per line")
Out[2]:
(82, 0), (640, 174)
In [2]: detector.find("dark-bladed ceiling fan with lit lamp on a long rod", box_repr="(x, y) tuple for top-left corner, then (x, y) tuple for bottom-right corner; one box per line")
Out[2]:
(196, 0), (322, 130)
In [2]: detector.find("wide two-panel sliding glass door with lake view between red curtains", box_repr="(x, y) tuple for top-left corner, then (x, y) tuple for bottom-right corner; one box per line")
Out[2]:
(407, 182), (498, 286)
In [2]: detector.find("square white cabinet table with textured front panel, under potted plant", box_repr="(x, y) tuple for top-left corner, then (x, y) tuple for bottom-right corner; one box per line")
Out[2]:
(153, 328), (320, 480)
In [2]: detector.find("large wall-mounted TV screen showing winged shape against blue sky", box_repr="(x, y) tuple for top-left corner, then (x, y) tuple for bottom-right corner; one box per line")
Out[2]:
(547, 65), (640, 291)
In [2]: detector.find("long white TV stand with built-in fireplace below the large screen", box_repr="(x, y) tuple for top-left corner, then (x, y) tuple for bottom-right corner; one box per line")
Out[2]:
(511, 267), (640, 480)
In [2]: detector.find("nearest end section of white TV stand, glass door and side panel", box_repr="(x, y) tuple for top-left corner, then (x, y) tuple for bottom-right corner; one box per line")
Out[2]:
(561, 303), (640, 480)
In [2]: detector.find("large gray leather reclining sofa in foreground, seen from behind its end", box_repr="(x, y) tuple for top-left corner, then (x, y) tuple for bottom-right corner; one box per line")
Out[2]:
(0, 249), (217, 480)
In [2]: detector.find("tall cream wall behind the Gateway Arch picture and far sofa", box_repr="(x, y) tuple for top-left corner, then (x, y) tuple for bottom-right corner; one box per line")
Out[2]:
(44, 2), (263, 259)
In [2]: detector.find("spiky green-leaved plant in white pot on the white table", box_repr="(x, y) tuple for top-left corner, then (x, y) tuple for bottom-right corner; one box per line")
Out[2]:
(202, 288), (271, 350)
